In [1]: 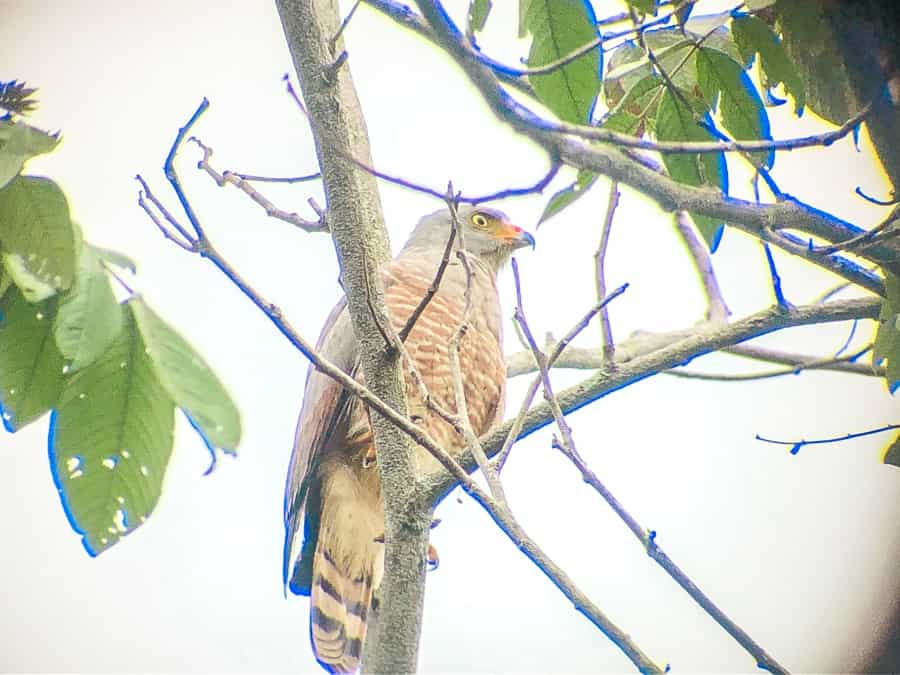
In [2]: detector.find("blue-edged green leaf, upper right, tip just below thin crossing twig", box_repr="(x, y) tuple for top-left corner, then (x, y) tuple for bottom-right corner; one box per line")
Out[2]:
(697, 47), (775, 168)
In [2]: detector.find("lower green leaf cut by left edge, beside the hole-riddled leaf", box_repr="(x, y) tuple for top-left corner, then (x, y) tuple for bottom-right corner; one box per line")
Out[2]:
(0, 288), (63, 431)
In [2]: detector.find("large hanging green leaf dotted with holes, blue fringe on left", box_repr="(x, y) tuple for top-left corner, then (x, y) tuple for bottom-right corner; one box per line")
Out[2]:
(50, 312), (175, 555)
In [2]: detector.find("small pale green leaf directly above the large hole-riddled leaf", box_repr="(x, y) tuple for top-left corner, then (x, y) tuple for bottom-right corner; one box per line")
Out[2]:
(54, 246), (122, 371)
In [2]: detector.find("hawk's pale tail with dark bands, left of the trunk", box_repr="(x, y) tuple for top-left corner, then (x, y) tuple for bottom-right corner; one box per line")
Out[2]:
(309, 536), (372, 673)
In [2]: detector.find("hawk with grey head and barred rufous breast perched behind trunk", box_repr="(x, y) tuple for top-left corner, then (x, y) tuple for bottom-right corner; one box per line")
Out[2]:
(284, 207), (534, 673)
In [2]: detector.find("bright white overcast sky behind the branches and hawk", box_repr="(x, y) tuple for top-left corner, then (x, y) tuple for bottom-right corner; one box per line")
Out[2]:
(0, 0), (900, 672)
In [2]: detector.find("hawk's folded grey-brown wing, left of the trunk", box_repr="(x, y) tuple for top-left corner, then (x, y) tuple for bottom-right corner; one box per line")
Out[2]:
(282, 298), (359, 594)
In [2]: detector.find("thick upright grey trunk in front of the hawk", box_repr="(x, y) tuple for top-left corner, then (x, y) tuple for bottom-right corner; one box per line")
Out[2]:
(276, 0), (431, 672)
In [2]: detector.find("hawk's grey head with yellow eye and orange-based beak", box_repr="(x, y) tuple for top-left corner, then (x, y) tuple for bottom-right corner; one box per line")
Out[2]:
(403, 205), (534, 272)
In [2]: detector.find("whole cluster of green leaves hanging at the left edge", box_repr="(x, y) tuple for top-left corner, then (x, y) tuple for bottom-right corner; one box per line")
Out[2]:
(0, 101), (241, 555)
